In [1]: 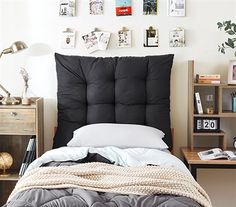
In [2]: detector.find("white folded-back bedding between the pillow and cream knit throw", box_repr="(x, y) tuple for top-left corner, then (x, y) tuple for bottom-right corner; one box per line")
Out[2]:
(27, 146), (189, 173)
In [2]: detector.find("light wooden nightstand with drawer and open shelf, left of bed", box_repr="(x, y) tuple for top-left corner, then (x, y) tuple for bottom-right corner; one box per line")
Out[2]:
(0, 98), (43, 206)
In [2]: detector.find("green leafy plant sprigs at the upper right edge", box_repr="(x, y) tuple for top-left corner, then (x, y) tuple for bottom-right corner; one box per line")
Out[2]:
(217, 20), (236, 57)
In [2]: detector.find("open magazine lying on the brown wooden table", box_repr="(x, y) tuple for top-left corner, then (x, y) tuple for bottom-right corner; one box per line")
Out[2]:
(198, 148), (236, 160)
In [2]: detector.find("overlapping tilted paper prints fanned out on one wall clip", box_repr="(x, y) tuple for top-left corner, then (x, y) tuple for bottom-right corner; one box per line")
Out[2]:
(82, 28), (111, 53)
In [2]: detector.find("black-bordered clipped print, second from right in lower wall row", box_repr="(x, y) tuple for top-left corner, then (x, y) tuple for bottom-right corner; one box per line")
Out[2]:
(143, 26), (159, 47)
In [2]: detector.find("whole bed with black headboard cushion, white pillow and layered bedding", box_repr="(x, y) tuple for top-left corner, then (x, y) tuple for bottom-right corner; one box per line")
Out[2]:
(4, 54), (211, 207)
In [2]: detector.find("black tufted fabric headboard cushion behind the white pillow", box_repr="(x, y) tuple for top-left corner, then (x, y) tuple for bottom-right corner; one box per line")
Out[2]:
(53, 53), (174, 148)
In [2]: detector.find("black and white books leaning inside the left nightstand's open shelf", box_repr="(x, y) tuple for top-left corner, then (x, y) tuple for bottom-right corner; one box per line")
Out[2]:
(19, 136), (36, 176)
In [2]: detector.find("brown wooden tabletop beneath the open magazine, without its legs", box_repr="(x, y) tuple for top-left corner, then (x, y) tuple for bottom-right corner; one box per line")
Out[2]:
(181, 147), (236, 165)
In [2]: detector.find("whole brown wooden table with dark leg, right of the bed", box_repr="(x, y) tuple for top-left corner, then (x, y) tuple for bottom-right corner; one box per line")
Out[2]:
(180, 147), (236, 180)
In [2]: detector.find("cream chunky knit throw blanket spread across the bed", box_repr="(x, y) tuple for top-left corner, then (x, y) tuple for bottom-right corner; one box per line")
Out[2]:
(8, 162), (212, 207)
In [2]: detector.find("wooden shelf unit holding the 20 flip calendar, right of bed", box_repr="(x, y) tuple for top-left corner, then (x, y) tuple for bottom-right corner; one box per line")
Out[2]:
(188, 60), (236, 150)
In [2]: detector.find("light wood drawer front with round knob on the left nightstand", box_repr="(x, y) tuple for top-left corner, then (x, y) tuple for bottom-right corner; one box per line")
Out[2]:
(0, 109), (36, 134)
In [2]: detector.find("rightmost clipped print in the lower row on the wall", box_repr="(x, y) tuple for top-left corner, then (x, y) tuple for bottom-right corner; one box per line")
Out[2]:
(169, 27), (185, 47)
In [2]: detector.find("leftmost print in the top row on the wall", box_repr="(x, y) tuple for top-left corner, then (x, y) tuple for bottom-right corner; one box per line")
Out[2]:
(59, 0), (75, 17)
